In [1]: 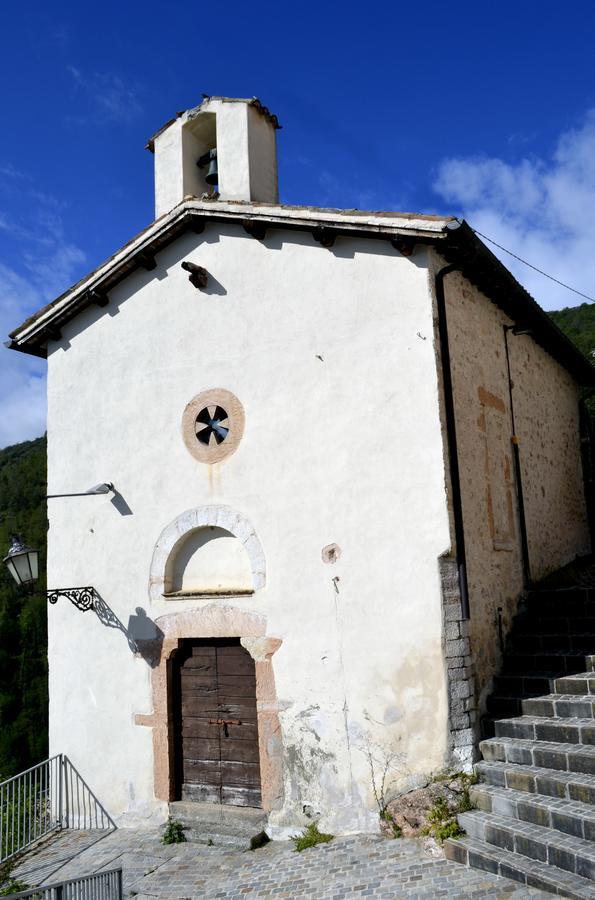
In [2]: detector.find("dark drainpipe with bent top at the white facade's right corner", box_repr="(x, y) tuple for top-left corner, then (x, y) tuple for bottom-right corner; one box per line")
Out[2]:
(434, 264), (469, 619)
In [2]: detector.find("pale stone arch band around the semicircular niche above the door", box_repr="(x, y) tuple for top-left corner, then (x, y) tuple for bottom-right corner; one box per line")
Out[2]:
(149, 505), (266, 600)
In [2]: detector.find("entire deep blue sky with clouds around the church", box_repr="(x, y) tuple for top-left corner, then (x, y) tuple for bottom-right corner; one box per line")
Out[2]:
(0, 0), (595, 446)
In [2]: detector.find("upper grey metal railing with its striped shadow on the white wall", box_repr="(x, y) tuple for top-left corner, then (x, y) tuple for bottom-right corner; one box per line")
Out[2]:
(0, 753), (115, 860)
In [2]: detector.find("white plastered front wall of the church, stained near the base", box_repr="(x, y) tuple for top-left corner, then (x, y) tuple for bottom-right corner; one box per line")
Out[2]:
(48, 225), (450, 831)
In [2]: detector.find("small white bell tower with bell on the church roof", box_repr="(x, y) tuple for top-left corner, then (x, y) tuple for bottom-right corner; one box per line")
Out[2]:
(147, 97), (281, 218)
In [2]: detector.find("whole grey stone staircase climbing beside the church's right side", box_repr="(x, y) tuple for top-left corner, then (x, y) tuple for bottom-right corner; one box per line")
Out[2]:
(444, 588), (595, 898)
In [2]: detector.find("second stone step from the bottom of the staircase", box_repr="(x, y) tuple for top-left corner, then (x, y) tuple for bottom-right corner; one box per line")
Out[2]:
(457, 811), (595, 880)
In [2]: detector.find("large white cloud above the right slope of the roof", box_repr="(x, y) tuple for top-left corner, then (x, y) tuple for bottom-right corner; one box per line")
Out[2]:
(434, 110), (595, 309)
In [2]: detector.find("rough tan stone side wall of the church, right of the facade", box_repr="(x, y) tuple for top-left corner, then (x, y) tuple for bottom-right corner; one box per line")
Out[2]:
(434, 256), (590, 715)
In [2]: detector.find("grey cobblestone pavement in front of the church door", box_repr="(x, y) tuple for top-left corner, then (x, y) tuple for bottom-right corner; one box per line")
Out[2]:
(16, 829), (552, 900)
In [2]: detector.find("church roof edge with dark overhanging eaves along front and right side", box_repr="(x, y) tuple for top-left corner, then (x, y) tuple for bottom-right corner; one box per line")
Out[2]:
(7, 204), (595, 387)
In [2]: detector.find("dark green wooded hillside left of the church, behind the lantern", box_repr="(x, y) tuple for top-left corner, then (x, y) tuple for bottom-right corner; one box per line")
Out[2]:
(0, 437), (48, 780)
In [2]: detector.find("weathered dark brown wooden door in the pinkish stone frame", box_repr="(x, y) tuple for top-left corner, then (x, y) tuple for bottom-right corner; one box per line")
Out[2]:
(174, 640), (261, 806)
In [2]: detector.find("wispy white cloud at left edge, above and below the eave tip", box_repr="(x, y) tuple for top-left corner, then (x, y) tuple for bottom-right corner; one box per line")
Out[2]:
(0, 200), (85, 447)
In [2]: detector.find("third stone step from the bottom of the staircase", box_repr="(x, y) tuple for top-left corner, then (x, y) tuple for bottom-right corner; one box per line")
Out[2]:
(469, 784), (595, 841)
